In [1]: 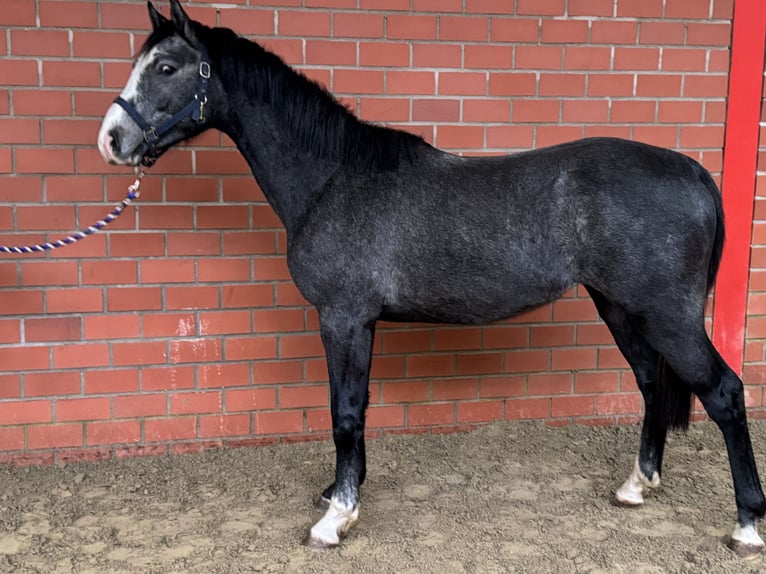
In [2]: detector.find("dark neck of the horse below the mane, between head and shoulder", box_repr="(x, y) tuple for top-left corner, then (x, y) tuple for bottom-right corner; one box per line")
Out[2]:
(221, 100), (337, 233)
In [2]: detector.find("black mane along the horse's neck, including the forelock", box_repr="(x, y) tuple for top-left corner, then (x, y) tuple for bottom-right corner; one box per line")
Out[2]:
(143, 23), (430, 170)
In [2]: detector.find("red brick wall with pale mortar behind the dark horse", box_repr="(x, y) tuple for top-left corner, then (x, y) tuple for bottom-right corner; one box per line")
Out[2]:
(0, 0), (744, 462)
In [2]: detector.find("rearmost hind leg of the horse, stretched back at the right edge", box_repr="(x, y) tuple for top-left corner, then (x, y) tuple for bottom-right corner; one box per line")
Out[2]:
(642, 320), (766, 558)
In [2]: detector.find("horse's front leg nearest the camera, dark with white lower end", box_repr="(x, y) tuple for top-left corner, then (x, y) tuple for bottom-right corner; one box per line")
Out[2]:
(308, 312), (374, 548)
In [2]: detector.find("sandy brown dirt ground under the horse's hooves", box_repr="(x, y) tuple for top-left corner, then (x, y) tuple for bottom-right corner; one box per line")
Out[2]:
(0, 422), (766, 574)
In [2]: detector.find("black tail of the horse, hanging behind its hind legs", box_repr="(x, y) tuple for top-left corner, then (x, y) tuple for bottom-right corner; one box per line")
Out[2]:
(652, 160), (724, 430)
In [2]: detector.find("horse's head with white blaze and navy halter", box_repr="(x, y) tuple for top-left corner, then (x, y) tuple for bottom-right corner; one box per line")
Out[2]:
(98, 0), (214, 166)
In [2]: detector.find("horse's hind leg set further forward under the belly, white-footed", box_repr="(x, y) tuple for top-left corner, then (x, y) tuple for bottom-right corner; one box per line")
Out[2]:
(586, 286), (667, 506)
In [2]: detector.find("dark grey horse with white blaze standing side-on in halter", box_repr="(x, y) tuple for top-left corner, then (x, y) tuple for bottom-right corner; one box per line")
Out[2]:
(97, 0), (766, 558)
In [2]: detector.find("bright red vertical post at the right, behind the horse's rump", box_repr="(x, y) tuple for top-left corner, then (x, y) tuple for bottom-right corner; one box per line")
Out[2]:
(713, 0), (766, 373)
